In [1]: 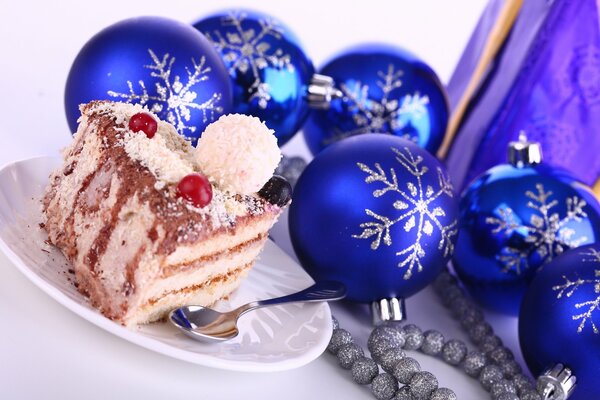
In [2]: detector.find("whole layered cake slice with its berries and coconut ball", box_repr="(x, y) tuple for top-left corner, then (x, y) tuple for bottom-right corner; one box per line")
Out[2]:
(43, 101), (290, 326)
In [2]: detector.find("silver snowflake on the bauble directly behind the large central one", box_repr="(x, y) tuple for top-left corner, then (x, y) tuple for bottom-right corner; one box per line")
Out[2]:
(324, 64), (429, 144)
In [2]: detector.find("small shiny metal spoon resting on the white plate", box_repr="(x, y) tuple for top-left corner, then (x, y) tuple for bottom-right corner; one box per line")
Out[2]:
(169, 281), (346, 342)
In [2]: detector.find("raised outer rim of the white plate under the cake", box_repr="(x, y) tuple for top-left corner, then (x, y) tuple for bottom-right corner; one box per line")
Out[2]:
(0, 156), (332, 372)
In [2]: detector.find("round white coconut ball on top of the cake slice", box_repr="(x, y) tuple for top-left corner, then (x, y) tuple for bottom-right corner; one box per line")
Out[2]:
(195, 114), (281, 194)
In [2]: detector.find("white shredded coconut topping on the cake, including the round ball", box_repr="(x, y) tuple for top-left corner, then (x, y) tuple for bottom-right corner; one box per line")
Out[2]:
(81, 102), (268, 228)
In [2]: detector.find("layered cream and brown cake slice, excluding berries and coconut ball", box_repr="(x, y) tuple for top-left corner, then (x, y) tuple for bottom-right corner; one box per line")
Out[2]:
(43, 102), (281, 325)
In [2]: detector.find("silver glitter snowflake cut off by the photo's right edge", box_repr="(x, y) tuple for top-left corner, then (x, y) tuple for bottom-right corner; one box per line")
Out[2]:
(552, 249), (600, 334)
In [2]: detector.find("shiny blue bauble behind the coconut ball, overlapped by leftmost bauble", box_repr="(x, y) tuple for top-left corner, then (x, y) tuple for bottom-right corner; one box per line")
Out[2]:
(194, 10), (315, 146)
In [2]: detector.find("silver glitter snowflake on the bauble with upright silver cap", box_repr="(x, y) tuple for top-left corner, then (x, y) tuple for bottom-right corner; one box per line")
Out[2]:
(486, 183), (588, 275)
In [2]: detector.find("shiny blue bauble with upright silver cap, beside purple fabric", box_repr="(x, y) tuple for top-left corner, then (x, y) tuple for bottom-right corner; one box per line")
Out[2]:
(453, 138), (600, 315)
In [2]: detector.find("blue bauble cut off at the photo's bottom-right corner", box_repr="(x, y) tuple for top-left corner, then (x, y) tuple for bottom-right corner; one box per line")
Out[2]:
(519, 244), (600, 400)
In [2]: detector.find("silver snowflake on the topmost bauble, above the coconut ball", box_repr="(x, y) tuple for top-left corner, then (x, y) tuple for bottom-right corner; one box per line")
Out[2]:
(205, 12), (294, 109)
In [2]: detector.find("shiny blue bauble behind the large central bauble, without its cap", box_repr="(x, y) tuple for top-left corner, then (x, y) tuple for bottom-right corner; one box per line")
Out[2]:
(304, 44), (448, 154)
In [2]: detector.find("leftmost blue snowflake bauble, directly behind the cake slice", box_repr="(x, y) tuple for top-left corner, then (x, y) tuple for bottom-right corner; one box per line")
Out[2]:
(65, 17), (232, 144)
